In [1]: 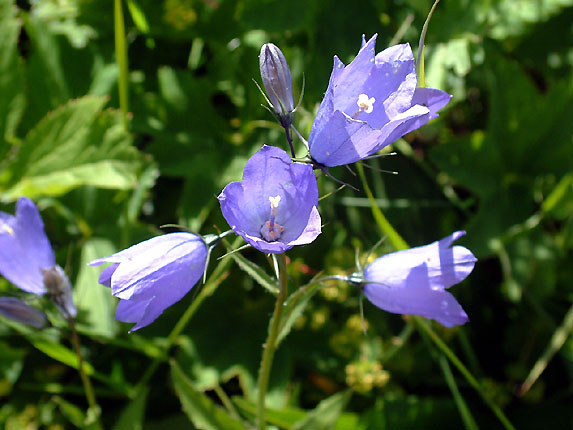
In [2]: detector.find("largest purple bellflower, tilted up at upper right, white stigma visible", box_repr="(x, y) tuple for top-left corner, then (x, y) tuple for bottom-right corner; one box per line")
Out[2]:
(308, 35), (451, 167)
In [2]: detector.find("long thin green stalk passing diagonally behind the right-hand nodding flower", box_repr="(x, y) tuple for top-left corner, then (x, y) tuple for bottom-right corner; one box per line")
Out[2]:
(356, 164), (515, 430)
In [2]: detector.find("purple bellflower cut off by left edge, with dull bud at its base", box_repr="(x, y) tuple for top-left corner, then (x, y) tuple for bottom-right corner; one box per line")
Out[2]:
(0, 197), (77, 318)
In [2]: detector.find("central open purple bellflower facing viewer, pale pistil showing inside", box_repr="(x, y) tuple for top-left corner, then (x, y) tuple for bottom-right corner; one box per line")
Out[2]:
(218, 146), (320, 254)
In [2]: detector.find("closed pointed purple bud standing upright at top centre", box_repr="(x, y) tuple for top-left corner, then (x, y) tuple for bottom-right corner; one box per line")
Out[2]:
(259, 43), (294, 128)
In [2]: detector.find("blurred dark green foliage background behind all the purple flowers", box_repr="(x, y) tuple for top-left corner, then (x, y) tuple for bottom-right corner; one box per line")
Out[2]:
(0, 0), (573, 430)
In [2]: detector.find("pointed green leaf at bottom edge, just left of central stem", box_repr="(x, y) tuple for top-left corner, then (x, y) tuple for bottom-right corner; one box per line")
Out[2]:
(171, 362), (245, 430)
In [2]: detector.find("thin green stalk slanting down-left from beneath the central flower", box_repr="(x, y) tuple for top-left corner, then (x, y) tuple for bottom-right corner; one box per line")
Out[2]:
(130, 237), (242, 398)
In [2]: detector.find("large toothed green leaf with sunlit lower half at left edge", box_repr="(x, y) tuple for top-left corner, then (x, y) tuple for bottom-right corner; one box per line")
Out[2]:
(0, 96), (141, 200)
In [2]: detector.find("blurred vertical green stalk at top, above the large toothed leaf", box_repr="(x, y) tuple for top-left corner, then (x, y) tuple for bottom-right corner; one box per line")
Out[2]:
(113, 0), (129, 132)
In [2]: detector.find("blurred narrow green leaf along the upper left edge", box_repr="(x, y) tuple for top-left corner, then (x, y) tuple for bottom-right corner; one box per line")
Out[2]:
(0, 0), (24, 152)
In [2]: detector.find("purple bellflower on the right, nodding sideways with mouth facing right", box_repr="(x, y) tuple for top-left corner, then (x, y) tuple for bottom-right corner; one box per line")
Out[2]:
(360, 231), (477, 327)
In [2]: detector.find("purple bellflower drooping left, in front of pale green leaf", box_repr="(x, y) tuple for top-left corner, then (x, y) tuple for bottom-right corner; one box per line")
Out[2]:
(89, 233), (208, 332)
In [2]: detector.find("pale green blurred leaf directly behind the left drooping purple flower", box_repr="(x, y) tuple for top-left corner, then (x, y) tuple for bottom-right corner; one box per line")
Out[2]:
(74, 238), (118, 337)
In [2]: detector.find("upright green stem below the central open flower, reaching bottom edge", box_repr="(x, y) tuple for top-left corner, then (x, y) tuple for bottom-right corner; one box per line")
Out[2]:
(257, 254), (288, 430)
